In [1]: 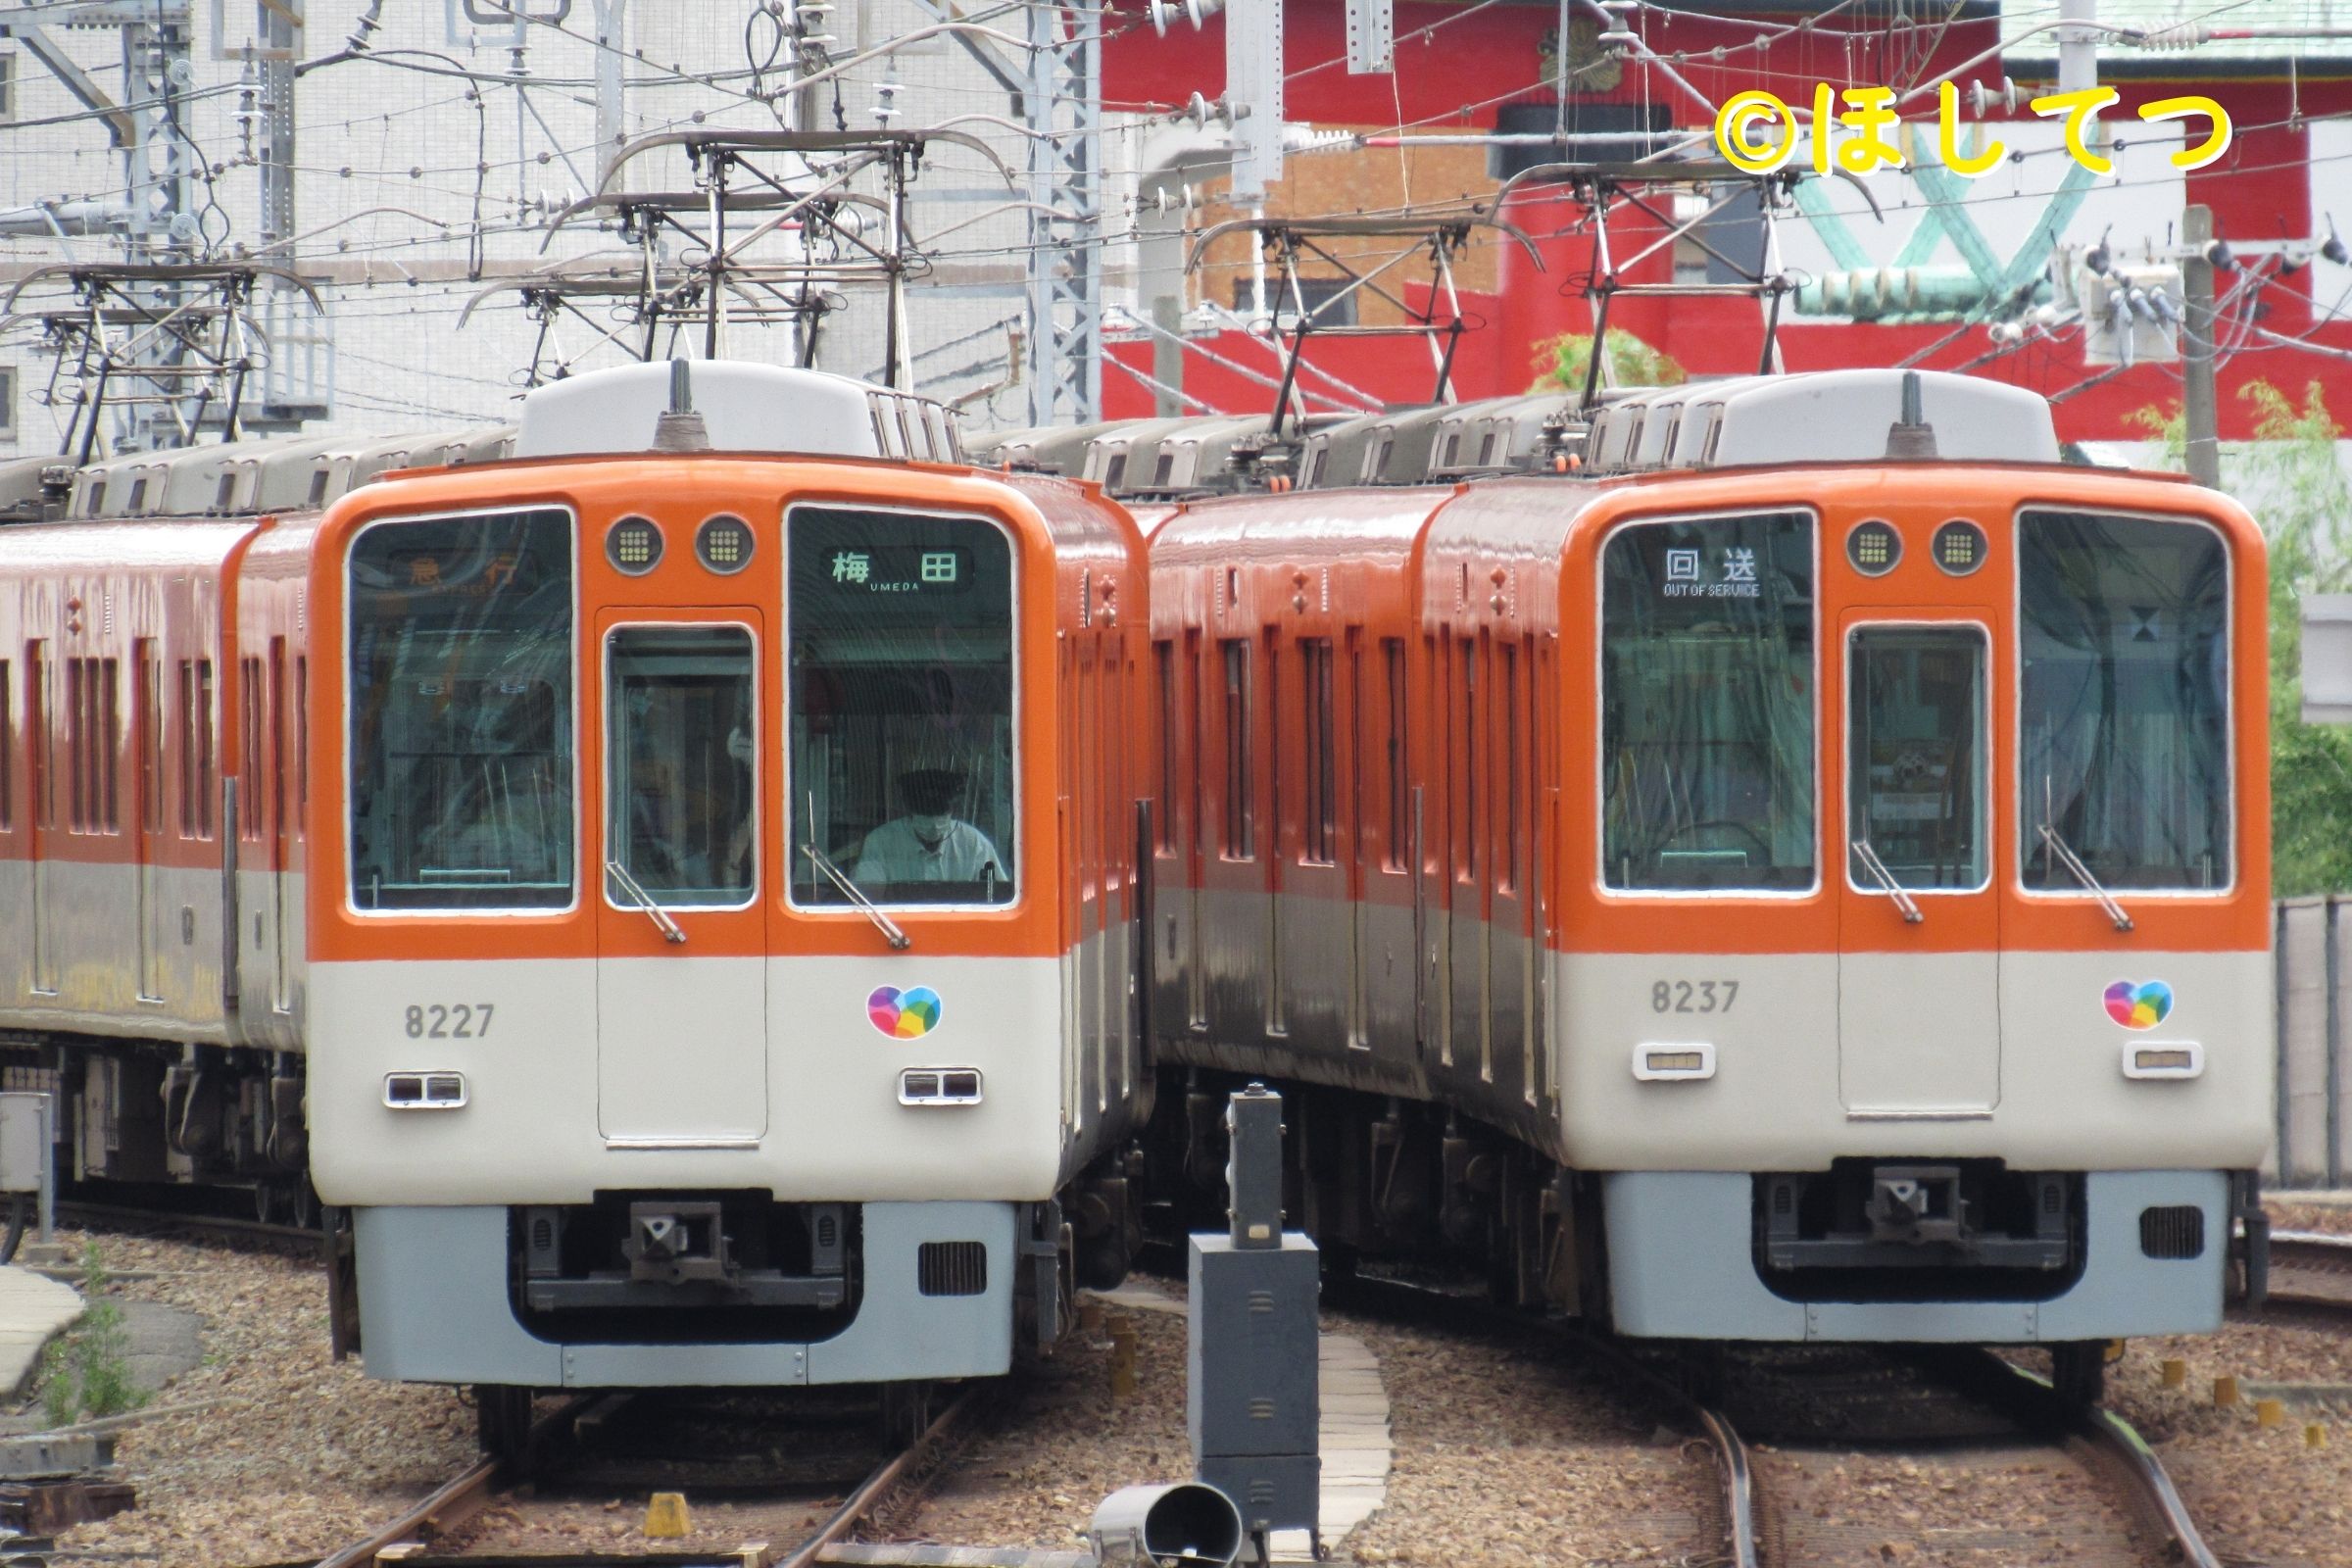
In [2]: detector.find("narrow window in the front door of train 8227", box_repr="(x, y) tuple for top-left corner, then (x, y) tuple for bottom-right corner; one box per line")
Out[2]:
(605, 625), (758, 909)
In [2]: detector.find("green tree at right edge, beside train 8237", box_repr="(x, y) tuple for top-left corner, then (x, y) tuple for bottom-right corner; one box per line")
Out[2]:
(2131, 381), (2352, 898)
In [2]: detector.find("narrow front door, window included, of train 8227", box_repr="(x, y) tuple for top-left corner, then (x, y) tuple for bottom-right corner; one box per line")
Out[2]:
(598, 609), (771, 1148)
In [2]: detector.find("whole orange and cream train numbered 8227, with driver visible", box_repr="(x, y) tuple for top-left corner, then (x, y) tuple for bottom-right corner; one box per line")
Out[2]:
(0, 365), (1151, 1441)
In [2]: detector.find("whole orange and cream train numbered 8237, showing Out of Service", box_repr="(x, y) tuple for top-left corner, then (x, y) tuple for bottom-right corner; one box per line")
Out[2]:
(1139, 371), (2272, 1387)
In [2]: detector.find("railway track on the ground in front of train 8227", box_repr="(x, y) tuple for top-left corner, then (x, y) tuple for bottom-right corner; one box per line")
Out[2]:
(318, 1390), (978, 1568)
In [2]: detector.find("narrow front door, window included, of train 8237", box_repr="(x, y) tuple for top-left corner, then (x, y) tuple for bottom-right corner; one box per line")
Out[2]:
(1837, 612), (2001, 1119)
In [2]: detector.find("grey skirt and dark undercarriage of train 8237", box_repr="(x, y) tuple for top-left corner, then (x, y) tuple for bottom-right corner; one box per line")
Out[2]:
(1146, 1069), (2260, 1394)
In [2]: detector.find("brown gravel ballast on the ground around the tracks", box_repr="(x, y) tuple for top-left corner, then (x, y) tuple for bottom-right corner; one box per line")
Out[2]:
(33, 1237), (2352, 1568)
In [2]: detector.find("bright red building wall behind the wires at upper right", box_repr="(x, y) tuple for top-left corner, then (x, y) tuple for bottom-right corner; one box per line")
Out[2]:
(1103, 0), (2352, 440)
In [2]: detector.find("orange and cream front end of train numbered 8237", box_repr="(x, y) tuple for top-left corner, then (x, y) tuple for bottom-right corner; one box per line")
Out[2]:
(1554, 434), (2272, 1371)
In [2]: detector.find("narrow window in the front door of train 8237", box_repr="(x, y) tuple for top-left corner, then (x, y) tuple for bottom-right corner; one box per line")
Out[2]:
(1846, 625), (1987, 894)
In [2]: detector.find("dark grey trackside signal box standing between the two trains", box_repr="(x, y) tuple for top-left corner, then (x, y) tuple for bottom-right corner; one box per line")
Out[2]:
(1186, 1086), (1322, 1561)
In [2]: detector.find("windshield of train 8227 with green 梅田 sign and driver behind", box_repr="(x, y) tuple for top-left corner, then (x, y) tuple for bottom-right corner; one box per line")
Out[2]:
(786, 506), (1016, 906)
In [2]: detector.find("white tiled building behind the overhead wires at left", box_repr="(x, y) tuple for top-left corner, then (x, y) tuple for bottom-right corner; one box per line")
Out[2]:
(0, 0), (1049, 454)
